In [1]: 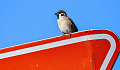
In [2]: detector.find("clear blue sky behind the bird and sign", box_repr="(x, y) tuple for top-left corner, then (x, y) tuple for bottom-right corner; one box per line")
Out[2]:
(0, 0), (120, 70)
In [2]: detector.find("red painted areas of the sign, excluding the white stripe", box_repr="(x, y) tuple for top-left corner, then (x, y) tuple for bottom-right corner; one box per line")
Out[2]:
(0, 30), (120, 70)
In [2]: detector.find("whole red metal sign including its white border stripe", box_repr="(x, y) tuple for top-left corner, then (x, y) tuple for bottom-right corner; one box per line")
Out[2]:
(0, 29), (120, 70)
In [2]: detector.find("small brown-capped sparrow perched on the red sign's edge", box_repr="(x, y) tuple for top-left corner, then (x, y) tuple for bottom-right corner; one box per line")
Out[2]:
(55, 10), (78, 38)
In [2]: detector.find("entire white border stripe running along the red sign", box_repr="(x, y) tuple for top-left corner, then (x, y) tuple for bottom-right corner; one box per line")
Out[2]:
(0, 34), (116, 70)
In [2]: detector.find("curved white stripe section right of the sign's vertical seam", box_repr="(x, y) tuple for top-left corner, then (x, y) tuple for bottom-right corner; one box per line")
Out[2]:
(88, 34), (116, 70)
